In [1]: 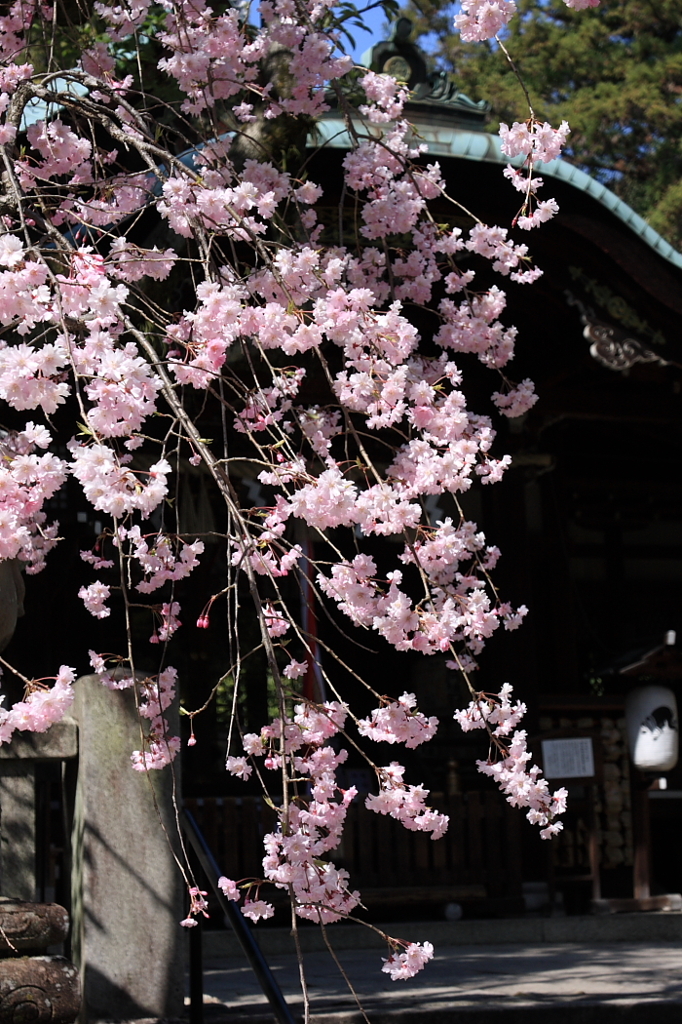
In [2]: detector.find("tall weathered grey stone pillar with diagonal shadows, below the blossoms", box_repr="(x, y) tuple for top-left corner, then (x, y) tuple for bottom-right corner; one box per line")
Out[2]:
(72, 676), (185, 1021)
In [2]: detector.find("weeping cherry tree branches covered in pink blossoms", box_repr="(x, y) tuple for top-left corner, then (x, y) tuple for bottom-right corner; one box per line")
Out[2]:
(0, 0), (594, 1007)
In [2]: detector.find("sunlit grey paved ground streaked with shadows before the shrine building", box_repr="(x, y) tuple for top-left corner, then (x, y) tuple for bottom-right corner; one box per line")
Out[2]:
(191, 942), (682, 1024)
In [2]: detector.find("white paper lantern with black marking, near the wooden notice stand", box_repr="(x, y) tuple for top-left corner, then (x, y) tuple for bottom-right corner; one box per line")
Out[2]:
(626, 686), (679, 771)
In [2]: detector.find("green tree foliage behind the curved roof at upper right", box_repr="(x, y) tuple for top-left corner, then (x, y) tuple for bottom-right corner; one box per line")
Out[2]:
(403, 0), (682, 248)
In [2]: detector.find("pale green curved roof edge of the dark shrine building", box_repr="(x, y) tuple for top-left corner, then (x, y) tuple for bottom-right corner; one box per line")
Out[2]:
(313, 117), (682, 269)
